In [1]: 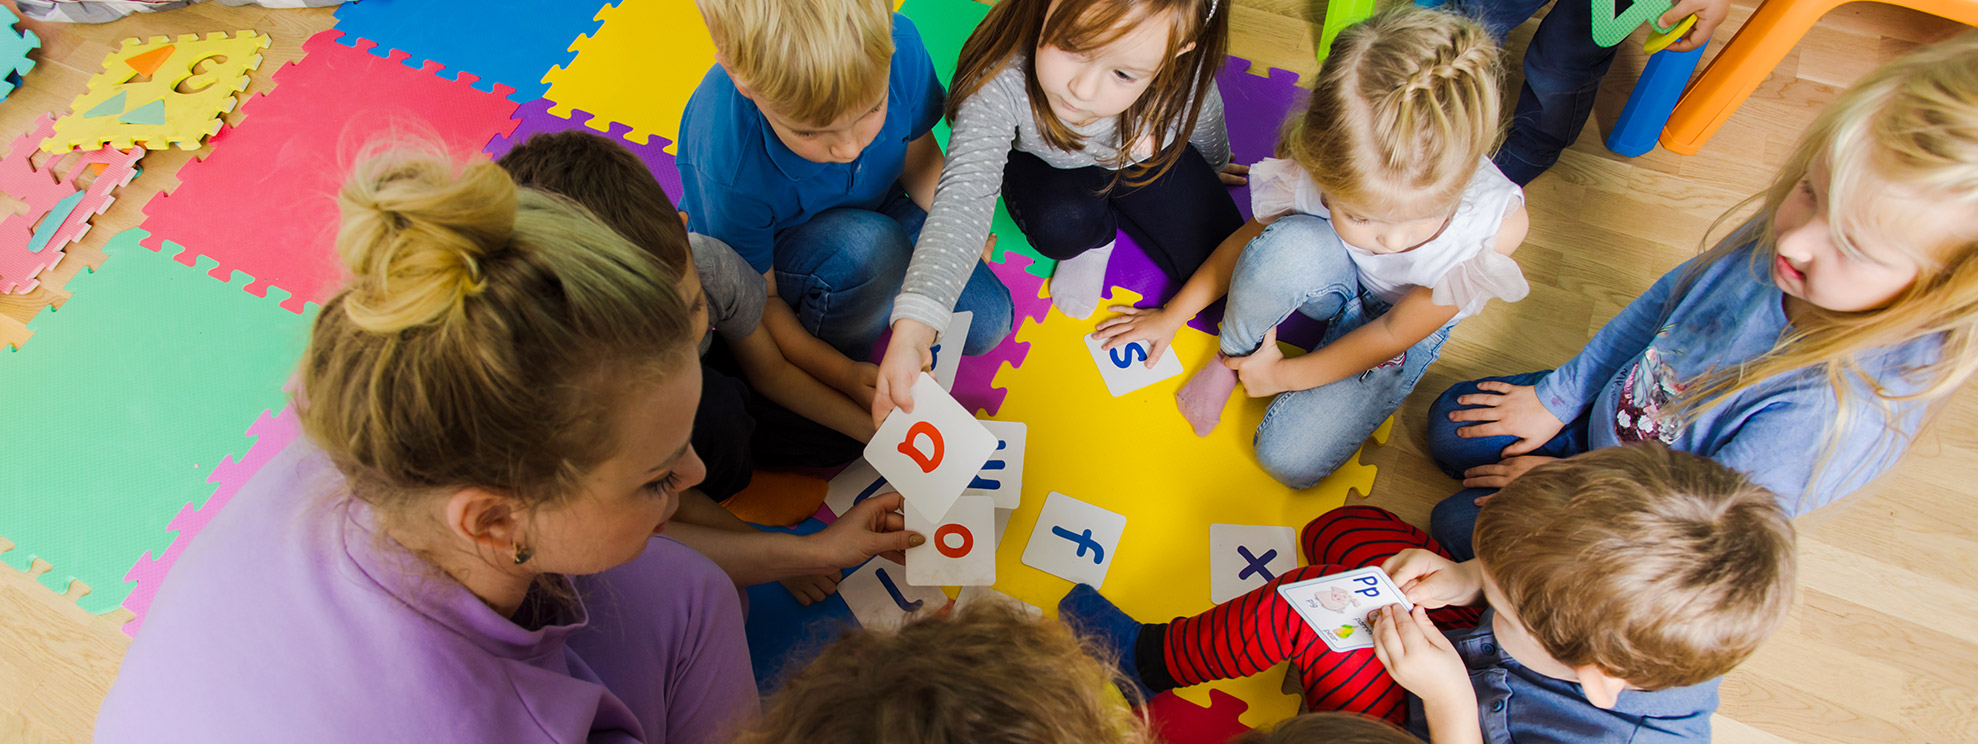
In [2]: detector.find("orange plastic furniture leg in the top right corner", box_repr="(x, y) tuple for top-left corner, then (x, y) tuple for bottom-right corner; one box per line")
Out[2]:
(1662, 0), (1978, 154)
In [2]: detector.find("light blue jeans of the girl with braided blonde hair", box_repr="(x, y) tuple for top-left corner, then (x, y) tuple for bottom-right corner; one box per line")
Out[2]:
(1220, 214), (1456, 489)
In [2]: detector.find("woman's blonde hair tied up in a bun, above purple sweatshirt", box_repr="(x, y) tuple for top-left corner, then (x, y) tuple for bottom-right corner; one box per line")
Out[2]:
(297, 143), (692, 516)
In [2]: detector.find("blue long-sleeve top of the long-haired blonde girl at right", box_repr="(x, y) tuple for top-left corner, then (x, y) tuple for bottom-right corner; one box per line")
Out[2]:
(1537, 245), (1942, 516)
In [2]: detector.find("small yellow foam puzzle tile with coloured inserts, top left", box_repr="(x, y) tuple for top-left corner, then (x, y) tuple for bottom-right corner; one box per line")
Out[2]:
(42, 32), (269, 152)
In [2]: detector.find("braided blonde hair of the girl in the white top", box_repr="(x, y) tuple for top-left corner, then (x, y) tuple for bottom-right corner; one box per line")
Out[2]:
(1278, 6), (1503, 208)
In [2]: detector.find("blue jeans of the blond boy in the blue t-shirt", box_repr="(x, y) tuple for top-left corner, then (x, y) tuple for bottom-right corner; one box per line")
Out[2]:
(775, 192), (1017, 360)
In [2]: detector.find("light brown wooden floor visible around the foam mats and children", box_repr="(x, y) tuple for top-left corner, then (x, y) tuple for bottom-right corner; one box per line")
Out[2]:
(0, 0), (1978, 744)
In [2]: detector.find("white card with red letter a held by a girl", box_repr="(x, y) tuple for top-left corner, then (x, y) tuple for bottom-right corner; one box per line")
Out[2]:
(864, 372), (997, 514)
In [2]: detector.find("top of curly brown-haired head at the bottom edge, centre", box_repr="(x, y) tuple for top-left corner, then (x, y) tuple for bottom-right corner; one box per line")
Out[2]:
(734, 602), (1153, 744)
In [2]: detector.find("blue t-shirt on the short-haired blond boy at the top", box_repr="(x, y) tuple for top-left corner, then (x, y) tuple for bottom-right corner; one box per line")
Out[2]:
(678, 14), (947, 271)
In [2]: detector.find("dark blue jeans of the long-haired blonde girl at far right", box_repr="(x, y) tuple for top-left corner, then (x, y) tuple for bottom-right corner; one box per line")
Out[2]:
(1428, 370), (1588, 560)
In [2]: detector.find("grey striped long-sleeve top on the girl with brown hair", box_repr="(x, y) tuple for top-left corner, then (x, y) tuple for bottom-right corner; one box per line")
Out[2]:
(892, 57), (1230, 330)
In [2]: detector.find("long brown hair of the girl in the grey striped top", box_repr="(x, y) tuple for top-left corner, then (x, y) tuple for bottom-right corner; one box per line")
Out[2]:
(947, 0), (1234, 186)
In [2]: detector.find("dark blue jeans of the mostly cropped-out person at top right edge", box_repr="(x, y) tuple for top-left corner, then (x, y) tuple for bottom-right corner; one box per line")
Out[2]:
(1450, 0), (1618, 186)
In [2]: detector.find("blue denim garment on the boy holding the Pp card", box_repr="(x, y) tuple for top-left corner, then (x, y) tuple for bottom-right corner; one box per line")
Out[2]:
(1408, 609), (1717, 744)
